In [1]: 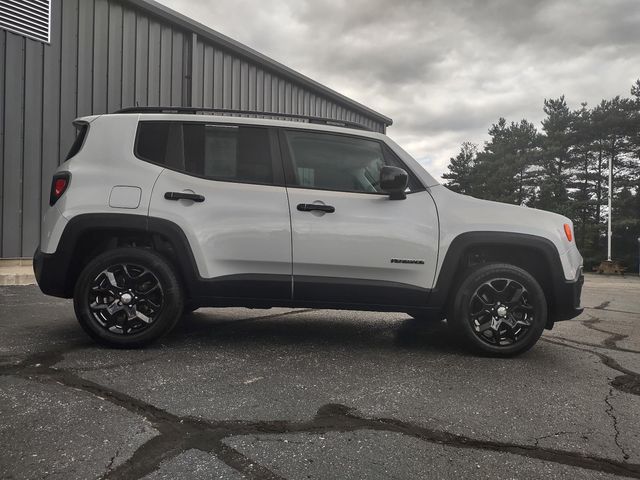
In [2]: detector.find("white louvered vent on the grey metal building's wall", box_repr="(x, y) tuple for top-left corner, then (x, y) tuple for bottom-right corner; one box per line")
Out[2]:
(0, 0), (51, 43)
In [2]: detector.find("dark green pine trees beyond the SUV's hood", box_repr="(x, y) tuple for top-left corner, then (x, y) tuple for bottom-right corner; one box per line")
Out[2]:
(442, 80), (640, 272)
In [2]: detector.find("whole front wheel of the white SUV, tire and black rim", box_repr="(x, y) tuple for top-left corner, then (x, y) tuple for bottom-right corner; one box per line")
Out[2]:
(447, 264), (547, 357)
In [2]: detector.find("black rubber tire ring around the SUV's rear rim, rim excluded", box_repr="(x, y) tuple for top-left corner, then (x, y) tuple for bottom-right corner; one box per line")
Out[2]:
(73, 248), (183, 348)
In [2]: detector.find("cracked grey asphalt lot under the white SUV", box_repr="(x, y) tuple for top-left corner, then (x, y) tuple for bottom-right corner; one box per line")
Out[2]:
(0, 275), (640, 480)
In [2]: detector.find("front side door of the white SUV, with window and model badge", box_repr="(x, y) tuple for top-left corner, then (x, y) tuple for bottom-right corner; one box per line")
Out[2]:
(281, 129), (438, 307)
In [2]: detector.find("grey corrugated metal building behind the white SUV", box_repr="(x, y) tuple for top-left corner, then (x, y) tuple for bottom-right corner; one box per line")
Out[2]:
(0, 0), (391, 258)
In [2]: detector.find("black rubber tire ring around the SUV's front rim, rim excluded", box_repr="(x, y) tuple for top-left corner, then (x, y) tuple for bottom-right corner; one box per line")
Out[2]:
(450, 264), (548, 357)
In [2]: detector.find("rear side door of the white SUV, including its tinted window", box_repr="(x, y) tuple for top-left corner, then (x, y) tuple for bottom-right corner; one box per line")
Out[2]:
(144, 121), (291, 300)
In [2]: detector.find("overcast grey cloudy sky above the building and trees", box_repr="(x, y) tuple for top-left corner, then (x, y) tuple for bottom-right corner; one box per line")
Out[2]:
(156, 0), (640, 176)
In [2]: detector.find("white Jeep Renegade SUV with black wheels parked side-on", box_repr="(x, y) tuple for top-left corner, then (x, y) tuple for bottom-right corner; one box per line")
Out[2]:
(34, 108), (583, 356)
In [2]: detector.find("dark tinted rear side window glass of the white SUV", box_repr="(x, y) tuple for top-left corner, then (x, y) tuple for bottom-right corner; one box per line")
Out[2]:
(136, 121), (274, 184)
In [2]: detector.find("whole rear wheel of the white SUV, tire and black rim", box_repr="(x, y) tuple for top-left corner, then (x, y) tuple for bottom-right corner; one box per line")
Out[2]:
(73, 247), (183, 348)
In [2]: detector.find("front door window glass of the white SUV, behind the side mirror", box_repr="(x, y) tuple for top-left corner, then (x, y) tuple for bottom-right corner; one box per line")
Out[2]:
(286, 131), (420, 193)
